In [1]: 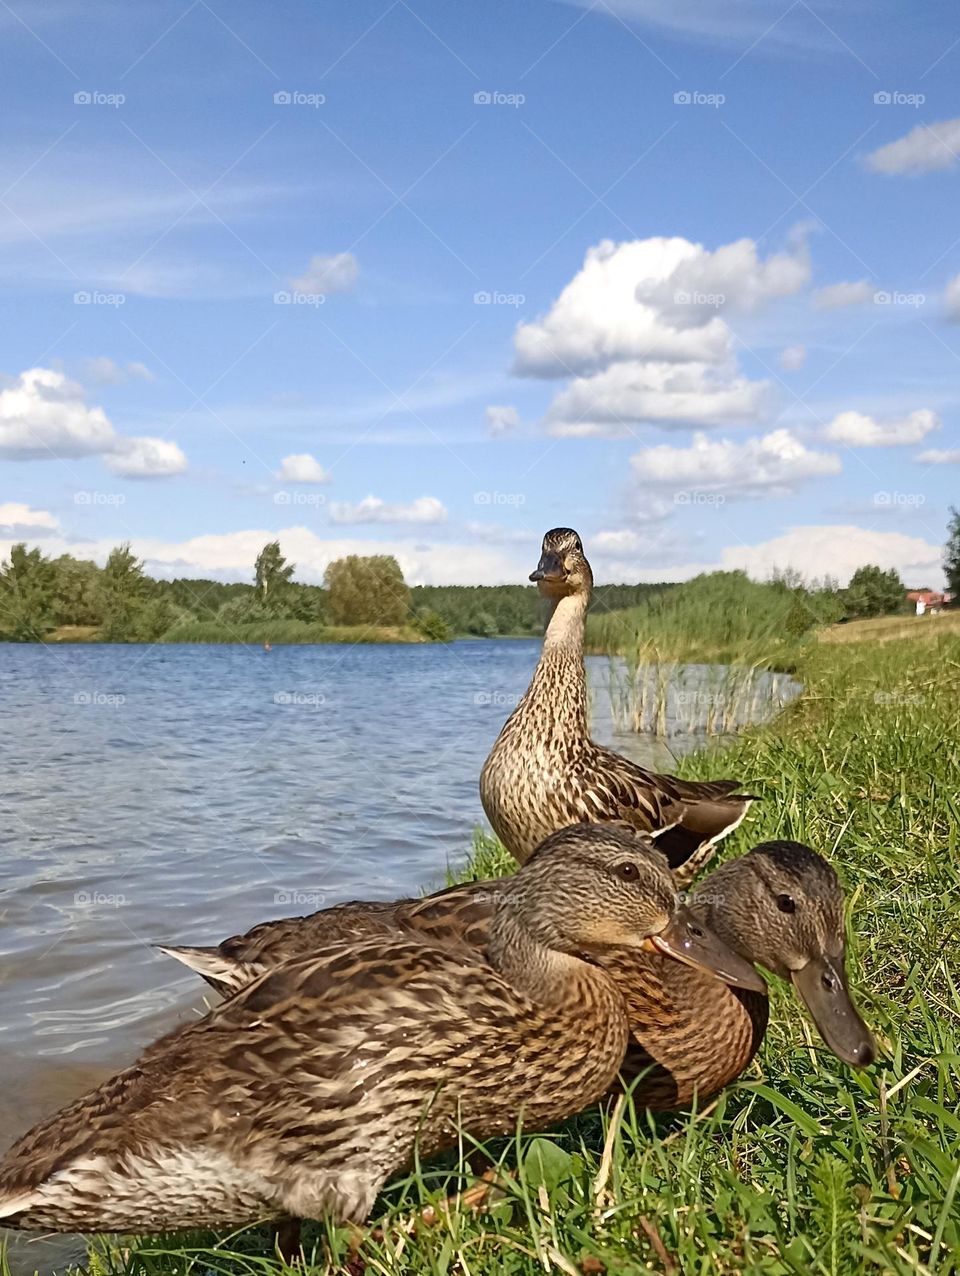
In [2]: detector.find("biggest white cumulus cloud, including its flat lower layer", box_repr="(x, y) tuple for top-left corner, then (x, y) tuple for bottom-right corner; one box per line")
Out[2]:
(513, 237), (809, 435)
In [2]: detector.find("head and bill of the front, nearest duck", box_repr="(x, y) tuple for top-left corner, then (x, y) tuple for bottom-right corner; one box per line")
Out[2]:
(510, 824), (766, 991)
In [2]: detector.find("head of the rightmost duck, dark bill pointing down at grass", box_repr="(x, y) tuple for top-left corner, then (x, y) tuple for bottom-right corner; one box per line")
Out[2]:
(693, 842), (877, 1068)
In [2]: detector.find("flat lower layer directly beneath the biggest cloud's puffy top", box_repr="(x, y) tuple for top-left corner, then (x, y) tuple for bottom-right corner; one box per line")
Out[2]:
(544, 362), (771, 436)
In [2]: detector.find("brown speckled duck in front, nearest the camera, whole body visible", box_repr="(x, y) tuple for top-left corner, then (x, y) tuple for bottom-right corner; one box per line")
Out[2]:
(0, 828), (755, 1233)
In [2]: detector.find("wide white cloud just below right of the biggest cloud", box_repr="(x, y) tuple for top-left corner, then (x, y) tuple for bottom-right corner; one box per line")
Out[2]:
(631, 430), (841, 498)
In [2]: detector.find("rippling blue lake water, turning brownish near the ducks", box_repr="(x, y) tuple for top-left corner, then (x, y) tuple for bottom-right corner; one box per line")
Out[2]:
(0, 641), (796, 1271)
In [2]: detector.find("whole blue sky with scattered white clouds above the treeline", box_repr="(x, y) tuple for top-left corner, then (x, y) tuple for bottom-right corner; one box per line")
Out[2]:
(0, 0), (960, 584)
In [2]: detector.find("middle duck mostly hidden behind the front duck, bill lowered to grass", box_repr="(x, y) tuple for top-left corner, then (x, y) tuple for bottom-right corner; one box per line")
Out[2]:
(162, 824), (877, 1111)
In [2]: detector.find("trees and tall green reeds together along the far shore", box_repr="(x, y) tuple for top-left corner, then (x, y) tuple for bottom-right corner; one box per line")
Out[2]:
(0, 510), (960, 648)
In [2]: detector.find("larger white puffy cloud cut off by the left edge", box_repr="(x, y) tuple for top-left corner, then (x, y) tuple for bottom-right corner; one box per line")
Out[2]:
(0, 367), (186, 479)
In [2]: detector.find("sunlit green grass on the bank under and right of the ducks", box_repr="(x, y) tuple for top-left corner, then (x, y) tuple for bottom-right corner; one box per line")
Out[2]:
(9, 637), (960, 1276)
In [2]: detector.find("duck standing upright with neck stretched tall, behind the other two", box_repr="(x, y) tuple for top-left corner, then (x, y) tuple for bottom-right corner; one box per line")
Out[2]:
(480, 527), (756, 880)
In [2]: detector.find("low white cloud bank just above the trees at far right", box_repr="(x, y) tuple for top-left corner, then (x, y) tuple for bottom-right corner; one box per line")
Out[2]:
(721, 526), (942, 584)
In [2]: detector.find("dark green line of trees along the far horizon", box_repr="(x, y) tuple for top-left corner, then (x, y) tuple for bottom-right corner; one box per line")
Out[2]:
(0, 509), (960, 642)
